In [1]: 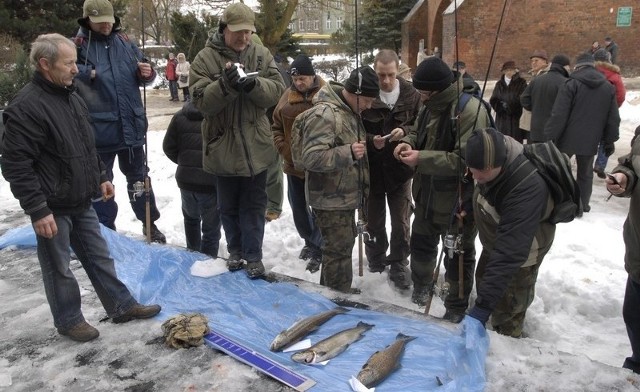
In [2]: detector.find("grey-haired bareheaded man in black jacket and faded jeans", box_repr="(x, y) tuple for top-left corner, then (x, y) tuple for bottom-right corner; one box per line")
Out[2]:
(2, 34), (160, 342)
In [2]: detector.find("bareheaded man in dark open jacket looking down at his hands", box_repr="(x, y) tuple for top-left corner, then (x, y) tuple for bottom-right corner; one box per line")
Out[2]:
(362, 49), (420, 290)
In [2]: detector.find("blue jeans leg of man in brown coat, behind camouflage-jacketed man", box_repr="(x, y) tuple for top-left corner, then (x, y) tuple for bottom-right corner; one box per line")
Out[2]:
(287, 174), (322, 249)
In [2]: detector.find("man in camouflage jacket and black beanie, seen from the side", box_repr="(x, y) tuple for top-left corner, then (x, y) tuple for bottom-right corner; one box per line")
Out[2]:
(292, 66), (380, 292)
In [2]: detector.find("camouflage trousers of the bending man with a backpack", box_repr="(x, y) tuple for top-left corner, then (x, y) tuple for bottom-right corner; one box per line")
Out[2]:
(476, 251), (542, 338)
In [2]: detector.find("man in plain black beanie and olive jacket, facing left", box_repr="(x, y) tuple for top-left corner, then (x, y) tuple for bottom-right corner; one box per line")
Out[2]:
(394, 57), (490, 322)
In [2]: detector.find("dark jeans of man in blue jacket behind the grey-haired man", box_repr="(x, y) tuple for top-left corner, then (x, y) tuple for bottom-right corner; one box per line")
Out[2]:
(93, 146), (160, 230)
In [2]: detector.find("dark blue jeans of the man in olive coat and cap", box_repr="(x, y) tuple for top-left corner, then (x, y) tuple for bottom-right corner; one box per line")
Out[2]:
(218, 170), (267, 262)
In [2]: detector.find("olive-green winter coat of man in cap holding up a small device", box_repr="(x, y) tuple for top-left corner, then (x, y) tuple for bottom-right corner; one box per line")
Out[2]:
(189, 32), (284, 177)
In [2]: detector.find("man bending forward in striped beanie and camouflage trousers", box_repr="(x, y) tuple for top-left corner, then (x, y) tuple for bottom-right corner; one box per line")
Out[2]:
(465, 128), (556, 338)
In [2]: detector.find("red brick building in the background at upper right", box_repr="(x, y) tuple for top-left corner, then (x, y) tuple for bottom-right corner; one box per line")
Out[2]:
(402, 0), (640, 79)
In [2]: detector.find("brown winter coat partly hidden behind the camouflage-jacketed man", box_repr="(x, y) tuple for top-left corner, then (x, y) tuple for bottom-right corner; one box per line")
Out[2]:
(271, 76), (326, 179)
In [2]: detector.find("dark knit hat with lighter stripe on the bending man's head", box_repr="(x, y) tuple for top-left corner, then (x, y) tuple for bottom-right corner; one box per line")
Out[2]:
(465, 128), (507, 170)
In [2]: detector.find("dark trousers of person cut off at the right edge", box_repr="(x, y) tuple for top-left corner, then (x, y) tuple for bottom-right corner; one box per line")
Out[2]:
(622, 277), (640, 373)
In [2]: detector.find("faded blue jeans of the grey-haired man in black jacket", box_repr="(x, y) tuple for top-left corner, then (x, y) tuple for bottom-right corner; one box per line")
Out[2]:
(36, 208), (136, 329)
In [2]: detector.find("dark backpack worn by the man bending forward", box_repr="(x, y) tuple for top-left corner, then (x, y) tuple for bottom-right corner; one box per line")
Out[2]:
(499, 141), (582, 224)
